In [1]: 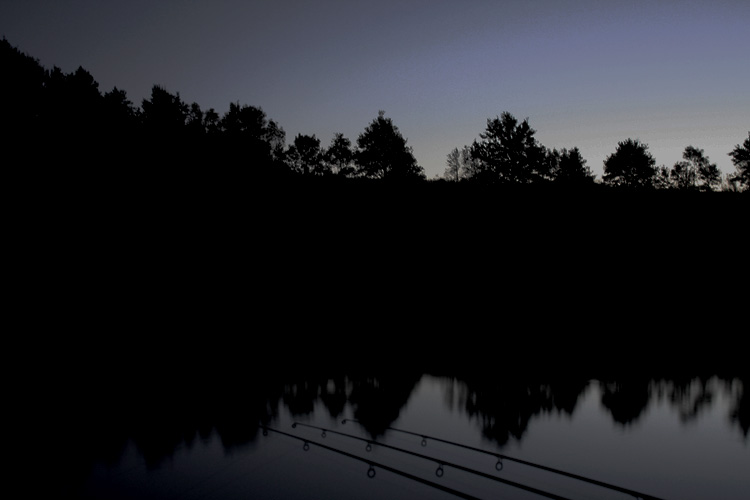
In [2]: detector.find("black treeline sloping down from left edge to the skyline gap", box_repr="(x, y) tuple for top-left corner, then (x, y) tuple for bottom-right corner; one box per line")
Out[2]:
(0, 39), (424, 188)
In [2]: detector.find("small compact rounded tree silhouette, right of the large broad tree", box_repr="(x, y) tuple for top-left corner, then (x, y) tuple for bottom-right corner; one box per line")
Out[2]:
(603, 139), (656, 188)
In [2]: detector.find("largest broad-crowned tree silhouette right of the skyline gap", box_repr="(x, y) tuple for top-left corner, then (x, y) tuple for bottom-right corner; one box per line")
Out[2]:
(471, 112), (549, 184)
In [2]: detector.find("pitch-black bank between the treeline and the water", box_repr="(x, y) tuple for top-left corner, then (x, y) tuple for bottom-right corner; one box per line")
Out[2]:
(14, 174), (750, 384)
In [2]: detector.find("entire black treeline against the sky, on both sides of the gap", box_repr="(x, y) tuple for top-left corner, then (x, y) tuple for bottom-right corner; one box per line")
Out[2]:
(0, 35), (750, 191)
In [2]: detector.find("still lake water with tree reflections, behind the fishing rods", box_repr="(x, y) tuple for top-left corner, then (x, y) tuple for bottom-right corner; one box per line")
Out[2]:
(66, 372), (750, 500)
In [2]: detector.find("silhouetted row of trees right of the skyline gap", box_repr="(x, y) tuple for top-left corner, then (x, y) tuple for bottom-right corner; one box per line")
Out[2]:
(444, 113), (750, 191)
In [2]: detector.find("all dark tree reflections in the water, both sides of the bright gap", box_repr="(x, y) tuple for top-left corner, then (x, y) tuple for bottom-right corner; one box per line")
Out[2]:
(69, 364), (750, 476)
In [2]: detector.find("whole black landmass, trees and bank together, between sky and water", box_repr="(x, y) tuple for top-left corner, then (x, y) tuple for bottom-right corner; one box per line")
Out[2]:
(7, 40), (750, 376)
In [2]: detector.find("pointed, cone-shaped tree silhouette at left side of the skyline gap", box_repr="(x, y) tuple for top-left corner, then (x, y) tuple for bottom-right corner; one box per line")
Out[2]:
(356, 111), (424, 180)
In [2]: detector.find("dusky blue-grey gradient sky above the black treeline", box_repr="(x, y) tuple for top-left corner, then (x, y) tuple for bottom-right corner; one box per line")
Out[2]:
(0, 0), (750, 178)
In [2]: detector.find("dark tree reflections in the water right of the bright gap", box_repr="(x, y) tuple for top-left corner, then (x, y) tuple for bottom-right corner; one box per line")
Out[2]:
(446, 376), (750, 446)
